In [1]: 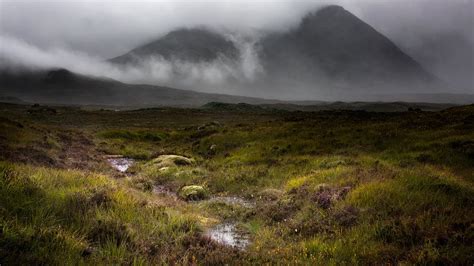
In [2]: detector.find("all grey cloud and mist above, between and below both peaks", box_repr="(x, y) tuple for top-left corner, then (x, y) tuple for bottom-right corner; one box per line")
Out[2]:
(0, 0), (474, 98)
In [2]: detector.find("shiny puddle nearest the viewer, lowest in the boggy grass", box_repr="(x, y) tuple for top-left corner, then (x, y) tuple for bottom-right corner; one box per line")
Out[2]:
(205, 223), (250, 250)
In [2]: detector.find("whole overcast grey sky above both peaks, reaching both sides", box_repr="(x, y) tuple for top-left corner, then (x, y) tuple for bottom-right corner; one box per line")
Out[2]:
(0, 0), (474, 87)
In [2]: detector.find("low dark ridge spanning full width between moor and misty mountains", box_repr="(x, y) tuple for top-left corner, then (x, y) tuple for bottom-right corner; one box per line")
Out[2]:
(0, 69), (474, 108)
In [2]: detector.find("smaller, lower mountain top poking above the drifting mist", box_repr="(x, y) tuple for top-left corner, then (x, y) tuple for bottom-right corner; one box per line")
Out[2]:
(109, 29), (238, 64)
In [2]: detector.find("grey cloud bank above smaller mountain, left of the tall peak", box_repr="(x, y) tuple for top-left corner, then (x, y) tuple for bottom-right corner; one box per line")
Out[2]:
(0, 0), (319, 58)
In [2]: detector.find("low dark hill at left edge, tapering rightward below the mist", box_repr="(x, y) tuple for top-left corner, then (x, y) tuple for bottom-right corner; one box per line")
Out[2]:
(0, 69), (279, 107)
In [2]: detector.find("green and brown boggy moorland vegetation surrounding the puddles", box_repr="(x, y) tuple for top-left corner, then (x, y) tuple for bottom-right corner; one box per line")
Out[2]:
(0, 104), (474, 265)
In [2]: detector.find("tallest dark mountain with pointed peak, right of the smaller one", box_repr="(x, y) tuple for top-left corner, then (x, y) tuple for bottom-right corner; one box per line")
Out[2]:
(261, 6), (439, 93)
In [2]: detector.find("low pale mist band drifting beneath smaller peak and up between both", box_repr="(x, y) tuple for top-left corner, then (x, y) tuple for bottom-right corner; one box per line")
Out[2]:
(0, 35), (263, 93)
